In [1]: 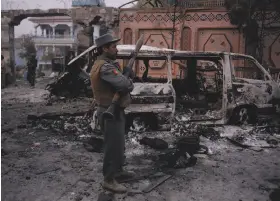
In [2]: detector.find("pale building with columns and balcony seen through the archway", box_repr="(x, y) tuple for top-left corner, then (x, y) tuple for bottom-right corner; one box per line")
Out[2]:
(29, 16), (100, 66)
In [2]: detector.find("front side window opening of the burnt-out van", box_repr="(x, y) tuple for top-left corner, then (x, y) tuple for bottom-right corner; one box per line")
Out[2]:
(231, 56), (265, 80)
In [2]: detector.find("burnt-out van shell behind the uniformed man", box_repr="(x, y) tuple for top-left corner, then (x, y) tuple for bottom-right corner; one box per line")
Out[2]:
(47, 45), (280, 130)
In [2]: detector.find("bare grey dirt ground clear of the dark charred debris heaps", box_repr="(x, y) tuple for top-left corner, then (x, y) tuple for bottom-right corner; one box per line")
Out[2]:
(1, 79), (280, 201)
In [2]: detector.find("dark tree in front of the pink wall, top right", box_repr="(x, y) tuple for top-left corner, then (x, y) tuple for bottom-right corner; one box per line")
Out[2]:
(225, 0), (280, 62)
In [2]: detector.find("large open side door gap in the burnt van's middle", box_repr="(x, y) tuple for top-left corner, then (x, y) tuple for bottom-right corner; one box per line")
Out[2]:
(173, 57), (223, 114)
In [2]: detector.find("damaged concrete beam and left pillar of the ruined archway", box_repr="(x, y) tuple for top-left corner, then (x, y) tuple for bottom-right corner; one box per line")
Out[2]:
(1, 6), (118, 78)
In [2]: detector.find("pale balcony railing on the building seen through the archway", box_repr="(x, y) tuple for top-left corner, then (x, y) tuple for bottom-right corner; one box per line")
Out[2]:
(33, 35), (75, 45)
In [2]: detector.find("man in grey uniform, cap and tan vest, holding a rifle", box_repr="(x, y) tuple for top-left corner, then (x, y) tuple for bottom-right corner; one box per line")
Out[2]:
(90, 34), (134, 193)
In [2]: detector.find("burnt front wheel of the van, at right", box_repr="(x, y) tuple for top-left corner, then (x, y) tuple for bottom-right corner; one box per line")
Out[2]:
(230, 106), (257, 125)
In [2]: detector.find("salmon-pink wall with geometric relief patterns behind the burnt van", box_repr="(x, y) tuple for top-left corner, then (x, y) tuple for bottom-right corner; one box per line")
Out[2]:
(119, 8), (280, 78)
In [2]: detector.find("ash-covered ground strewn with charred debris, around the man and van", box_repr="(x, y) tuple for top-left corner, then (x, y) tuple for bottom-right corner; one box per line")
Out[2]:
(1, 78), (280, 201)
